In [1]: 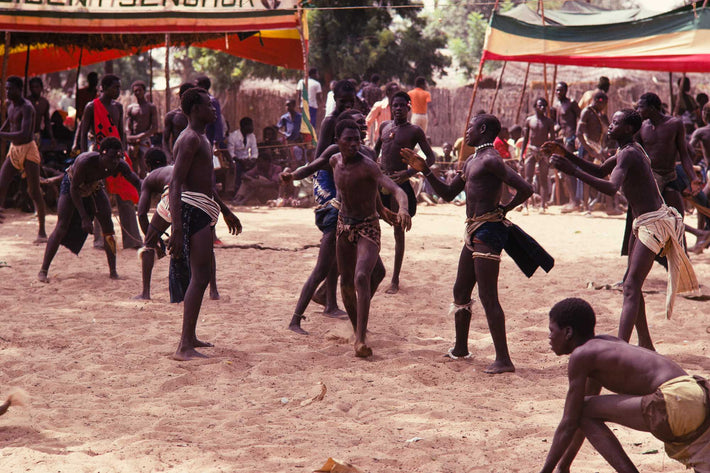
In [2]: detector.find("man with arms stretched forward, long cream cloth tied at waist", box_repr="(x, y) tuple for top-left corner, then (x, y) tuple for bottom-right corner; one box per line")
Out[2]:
(543, 109), (698, 350)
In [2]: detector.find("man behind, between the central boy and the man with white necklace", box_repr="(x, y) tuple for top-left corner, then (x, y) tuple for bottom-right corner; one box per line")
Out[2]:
(375, 91), (436, 294)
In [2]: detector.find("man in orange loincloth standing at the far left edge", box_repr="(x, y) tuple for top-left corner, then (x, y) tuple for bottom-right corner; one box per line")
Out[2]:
(0, 76), (47, 243)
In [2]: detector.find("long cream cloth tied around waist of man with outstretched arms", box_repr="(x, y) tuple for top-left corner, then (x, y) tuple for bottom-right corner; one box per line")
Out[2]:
(633, 204), (700, 319)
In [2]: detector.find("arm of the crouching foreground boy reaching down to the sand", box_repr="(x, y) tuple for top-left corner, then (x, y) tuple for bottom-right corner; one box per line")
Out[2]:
(540, 355), (587, 473)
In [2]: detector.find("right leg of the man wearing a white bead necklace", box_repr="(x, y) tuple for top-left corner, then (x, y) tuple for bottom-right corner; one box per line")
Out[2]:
(473, 242), (515, 374)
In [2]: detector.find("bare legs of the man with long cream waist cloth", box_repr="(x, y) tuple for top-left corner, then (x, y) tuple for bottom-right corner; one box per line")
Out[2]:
(618, 239), (656, 350)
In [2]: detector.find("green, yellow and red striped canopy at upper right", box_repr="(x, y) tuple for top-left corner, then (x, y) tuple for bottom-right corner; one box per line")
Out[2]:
(483, 2), (710, 72)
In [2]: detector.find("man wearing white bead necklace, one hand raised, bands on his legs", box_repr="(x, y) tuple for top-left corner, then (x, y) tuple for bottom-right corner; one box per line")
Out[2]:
(402, 114), (533, 374)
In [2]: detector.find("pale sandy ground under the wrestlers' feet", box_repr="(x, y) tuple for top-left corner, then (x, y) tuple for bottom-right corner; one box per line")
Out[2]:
(0, 201), (710, 473)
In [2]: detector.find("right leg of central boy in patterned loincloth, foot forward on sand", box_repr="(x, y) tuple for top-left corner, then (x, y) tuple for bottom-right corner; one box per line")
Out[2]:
(355, 238), (380, 358)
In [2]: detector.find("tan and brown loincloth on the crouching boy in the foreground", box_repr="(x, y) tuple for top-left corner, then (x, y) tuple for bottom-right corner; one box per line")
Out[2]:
(641, 376), (710, 472)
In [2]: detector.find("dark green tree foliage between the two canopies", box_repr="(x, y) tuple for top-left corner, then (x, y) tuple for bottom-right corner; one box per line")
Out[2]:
(309, 0), (450, 83)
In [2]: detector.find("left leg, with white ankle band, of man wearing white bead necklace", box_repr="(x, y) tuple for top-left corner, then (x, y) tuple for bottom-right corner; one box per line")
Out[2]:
(450, 246), (476, 357)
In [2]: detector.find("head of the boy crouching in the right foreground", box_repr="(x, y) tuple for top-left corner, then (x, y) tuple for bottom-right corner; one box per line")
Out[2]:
(548, 297), (597, 355)
